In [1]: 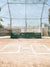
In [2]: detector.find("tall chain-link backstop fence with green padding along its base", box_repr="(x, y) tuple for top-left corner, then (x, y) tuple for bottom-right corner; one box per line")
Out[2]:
(0, 0), (50, 38)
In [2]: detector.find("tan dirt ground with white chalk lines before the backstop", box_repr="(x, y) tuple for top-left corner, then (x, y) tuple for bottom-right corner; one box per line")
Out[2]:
(0, 38), (50, 67)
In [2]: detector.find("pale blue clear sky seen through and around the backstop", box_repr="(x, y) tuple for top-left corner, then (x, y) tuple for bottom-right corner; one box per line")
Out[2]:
(0, 0), (50, 26)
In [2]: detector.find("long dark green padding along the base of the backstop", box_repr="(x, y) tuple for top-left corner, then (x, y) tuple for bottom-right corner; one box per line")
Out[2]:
(11, 32), (41, 38)
